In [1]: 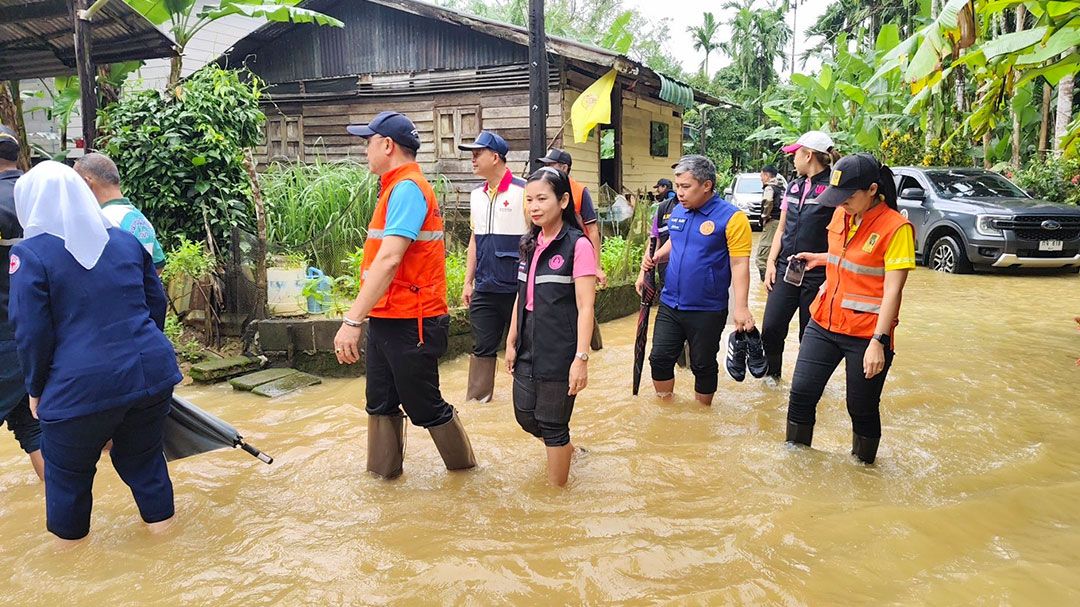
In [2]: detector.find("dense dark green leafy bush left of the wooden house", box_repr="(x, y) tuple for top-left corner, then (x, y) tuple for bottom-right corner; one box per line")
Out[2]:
(98, 65), (266, 249)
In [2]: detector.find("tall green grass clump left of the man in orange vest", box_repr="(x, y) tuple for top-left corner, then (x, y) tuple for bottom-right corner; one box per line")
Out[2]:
(259, 161), (379, 275)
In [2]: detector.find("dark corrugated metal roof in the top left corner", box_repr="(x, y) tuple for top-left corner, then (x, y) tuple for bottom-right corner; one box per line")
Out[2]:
(0, 0), (175, 80)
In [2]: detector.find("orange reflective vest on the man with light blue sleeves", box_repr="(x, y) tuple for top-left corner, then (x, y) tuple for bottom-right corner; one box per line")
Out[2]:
(361, 162), (447, 343)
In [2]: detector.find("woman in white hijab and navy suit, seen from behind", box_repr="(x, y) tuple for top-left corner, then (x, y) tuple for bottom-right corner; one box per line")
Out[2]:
(9, 162), (181, 540)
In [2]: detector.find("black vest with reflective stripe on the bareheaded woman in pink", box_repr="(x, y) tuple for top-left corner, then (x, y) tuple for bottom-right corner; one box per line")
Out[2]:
(514, 226), (584, 381)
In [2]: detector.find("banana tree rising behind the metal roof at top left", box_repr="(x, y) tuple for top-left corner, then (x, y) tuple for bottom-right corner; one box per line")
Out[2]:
(125, 0), (345, 91)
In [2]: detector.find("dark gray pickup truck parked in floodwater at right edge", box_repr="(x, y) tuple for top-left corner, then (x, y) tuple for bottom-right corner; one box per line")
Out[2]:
(893, 166), (1080, 273)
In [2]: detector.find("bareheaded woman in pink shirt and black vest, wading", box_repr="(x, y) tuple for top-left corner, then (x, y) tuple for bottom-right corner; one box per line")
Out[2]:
(507, 166), (596, 487)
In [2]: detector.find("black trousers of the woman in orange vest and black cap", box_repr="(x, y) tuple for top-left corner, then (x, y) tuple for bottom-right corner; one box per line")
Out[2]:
(787, 321), (893, 439)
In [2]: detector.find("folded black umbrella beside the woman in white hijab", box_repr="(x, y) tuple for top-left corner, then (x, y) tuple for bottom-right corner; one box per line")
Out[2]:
(165, 394), (273, 463)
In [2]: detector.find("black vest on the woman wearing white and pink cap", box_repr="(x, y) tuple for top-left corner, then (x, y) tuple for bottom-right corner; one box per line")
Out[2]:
(777, 168), (836, 279)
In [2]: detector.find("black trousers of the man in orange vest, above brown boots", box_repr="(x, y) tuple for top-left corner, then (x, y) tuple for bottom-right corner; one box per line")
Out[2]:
(365, 314), (454, 428)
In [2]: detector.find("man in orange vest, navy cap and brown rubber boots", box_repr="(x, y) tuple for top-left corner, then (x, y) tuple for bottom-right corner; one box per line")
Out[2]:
(334, 111), (476, 478)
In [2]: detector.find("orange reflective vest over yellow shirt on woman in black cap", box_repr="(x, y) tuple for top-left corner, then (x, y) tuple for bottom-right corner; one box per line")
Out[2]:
(810, 204), (908, 343)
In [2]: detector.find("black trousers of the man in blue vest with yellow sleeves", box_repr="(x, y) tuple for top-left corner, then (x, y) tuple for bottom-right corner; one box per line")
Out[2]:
(649, 304), (728, 394)
